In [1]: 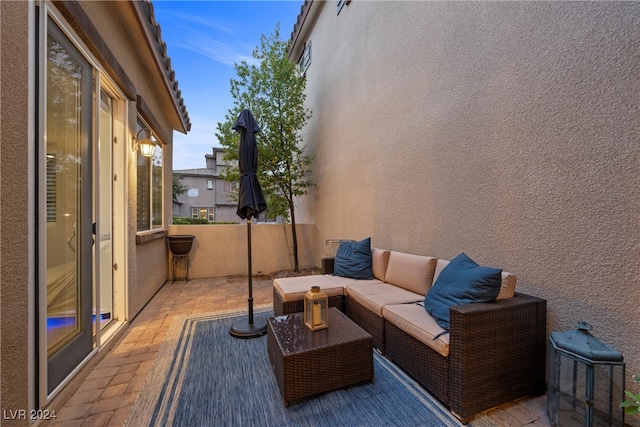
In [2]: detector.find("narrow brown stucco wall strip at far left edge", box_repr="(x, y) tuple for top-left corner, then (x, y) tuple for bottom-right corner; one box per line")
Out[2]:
(0, 2), (32, 425)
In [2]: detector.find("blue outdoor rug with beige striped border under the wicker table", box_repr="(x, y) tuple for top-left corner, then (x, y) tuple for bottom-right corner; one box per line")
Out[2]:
(127, 309), (490, 427)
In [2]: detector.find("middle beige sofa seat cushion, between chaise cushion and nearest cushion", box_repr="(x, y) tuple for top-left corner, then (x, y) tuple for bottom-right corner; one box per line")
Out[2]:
(345, 283), (424, 317)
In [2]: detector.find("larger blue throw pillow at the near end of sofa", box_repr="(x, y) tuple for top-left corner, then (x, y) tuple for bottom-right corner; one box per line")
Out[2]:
(424, 253), (502, 331)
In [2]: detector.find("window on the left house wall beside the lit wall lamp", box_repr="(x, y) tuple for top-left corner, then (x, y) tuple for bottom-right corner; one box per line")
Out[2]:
(137, 120), (164, 231)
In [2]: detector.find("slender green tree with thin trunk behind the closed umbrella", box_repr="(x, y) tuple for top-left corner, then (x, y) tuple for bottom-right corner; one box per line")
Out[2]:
(216, 24), (313, 271)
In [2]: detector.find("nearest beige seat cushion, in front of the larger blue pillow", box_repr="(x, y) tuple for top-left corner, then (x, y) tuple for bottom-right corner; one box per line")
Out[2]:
(382, 303), (449, 357)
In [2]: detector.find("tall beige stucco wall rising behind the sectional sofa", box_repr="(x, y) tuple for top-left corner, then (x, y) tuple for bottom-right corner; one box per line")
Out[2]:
(302, 1), (640, 388)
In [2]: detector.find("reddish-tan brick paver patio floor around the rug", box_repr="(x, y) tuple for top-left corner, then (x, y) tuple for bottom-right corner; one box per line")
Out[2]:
(48, 277), (550, 427)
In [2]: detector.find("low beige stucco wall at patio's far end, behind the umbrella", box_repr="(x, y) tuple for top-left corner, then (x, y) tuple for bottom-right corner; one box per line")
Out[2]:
(169, 223), (320, 279)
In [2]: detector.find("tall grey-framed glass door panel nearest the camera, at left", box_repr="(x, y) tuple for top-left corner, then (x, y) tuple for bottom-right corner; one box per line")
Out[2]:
(41, 19), (93, 393)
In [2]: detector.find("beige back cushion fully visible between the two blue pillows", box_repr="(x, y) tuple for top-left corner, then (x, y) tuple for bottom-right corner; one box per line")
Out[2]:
(384, 251), (436, 295)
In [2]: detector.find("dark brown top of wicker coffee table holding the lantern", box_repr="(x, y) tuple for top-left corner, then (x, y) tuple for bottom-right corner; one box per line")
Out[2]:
(267, 307), (371, 355)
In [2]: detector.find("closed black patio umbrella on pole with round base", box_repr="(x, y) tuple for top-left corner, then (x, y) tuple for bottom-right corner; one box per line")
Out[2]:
(229, 109), (267, 338)
